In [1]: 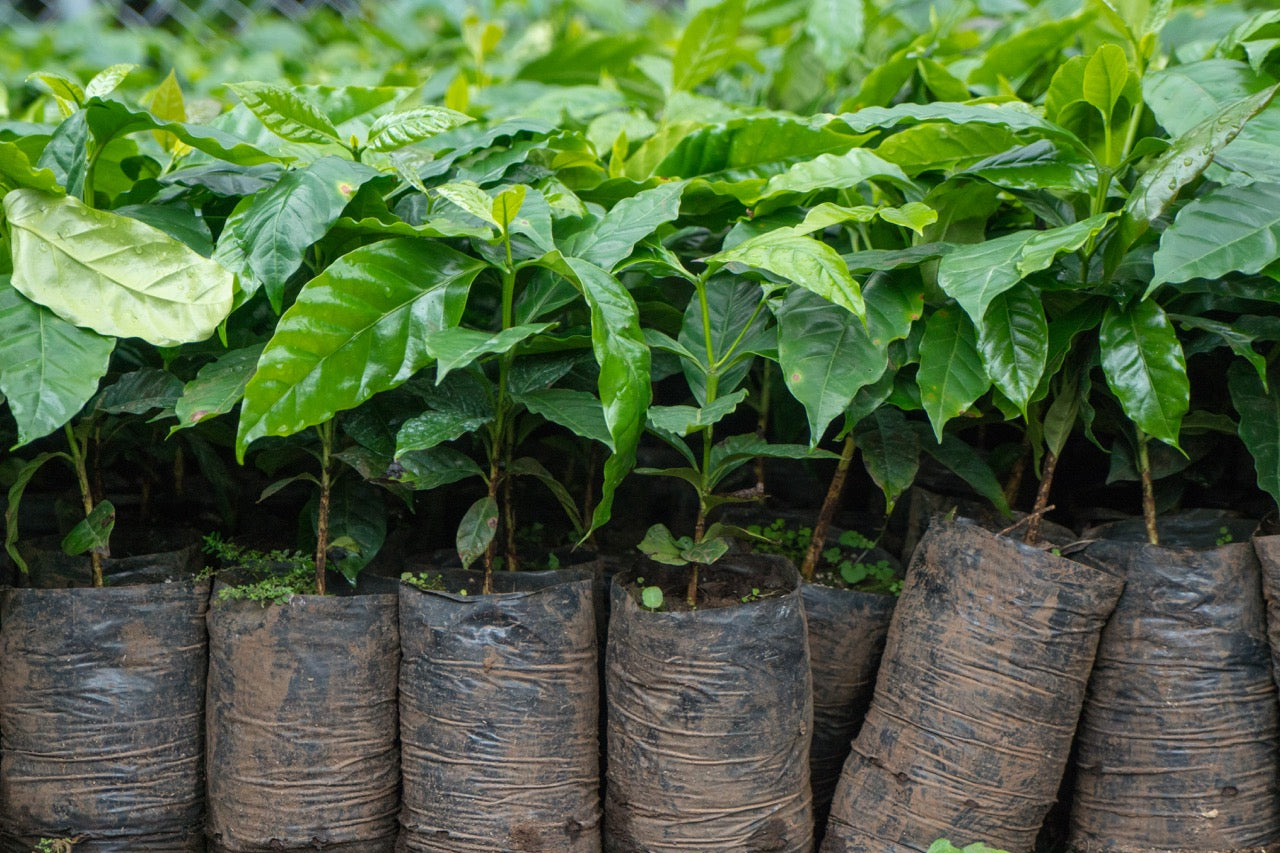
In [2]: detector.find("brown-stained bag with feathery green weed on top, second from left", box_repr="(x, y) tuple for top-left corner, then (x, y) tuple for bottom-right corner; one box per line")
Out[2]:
(207, 592), (399, 853)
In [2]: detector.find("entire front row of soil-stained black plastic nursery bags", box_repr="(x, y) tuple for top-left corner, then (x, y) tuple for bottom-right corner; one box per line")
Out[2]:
(0, 507), (1280, 853)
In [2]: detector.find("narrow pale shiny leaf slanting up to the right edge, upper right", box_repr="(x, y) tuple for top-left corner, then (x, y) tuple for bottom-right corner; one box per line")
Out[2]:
(1120, 83), (1280, 239)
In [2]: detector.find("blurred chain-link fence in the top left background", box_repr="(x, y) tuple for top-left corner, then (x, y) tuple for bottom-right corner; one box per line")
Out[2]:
(0, 0), (358, 33)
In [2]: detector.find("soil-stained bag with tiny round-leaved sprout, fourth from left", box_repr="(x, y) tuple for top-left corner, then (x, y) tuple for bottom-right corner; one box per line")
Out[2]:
(604, 556), (813, 853)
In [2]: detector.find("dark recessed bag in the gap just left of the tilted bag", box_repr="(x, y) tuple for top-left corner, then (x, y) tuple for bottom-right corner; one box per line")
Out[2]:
(800, 584), (897, 840)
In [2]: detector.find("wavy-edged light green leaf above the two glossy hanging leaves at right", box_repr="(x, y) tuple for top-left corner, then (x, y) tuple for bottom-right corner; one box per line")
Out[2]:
(938, 213), (1115, 327)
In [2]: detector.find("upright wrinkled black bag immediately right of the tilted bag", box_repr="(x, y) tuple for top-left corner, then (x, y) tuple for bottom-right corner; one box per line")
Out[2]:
(1070, 525), (1280, 853)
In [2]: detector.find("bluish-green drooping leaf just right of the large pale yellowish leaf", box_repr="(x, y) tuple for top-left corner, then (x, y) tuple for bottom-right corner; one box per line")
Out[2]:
(230, 158), (378, 311)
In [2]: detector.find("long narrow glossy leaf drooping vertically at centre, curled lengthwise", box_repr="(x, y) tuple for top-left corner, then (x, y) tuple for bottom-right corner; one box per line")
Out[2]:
(564, 257), (653, 530)
